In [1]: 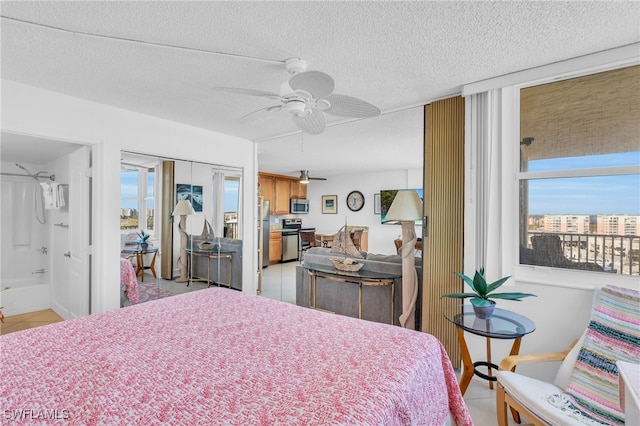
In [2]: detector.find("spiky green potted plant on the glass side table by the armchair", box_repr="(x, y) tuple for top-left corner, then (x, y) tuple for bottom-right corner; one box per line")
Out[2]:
(442, 268), (536, 319)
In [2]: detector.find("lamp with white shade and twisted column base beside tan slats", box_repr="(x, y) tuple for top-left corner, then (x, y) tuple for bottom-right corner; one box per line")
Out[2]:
(385, 190), (422, 330)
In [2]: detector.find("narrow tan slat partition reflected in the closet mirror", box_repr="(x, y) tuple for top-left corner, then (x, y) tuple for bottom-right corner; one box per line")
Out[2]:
(161, 161), (176, 280)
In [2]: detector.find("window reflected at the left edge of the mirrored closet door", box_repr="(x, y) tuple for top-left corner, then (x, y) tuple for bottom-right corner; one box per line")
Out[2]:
(120, 165), (157, 235)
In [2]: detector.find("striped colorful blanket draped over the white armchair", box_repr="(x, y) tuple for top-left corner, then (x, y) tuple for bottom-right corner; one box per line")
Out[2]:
(552, 286), (640, 425)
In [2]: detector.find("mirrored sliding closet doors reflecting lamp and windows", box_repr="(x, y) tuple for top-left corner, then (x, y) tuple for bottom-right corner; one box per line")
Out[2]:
(120, 151), (243, 306)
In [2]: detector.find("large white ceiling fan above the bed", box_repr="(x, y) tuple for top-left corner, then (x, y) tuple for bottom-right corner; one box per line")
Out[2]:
(213, 58), (380, 135)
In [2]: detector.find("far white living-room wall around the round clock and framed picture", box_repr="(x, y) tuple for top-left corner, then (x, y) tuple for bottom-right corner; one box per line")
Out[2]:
(300, 169), (422, 254)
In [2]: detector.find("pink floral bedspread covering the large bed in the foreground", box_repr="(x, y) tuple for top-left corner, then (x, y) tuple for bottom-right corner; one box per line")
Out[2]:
(0, 287), (472, 425)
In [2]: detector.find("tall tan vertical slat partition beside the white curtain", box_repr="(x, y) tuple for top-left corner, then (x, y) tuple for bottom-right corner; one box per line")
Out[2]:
(422, 96), (464, 367)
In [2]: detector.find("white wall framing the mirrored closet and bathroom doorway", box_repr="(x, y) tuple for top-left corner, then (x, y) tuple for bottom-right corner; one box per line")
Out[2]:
(2, 80), (257, 312)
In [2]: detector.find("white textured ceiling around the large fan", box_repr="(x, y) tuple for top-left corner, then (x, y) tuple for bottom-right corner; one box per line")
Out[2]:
(0, 1), (640, 175)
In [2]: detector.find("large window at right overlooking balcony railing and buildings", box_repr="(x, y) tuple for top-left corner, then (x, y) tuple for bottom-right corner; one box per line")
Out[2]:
(517, 66), (640, 276)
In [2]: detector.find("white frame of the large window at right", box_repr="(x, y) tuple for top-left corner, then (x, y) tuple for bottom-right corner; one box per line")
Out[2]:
(462, 43), (640, 289)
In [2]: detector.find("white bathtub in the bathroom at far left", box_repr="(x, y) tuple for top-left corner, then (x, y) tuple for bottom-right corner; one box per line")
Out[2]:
(0, 273), (50, 317)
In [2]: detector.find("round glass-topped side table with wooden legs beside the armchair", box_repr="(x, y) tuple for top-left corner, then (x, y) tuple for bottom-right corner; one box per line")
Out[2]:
(445, 305), (536, 395)
